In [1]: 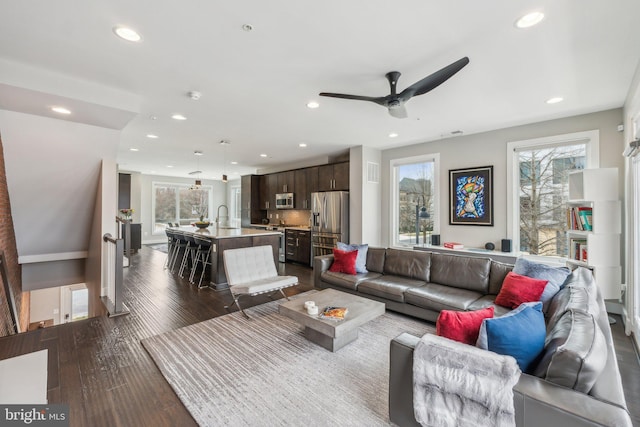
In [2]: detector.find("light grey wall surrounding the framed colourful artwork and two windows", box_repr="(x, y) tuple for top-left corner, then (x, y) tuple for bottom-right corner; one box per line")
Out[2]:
(381, 109), (624, 247)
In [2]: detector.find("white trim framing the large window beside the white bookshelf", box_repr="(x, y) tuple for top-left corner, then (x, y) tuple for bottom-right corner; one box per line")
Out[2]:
(506, 129), (600, 258)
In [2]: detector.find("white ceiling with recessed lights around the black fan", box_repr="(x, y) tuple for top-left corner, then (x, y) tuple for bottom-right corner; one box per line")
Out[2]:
(0, 0), (640, 179)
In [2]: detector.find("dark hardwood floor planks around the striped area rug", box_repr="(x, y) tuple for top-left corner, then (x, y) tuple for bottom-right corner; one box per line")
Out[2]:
(0, 246), (640, 426)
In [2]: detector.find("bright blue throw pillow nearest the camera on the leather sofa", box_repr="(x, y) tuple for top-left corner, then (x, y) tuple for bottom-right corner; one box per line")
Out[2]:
(476, 301), (546, 372)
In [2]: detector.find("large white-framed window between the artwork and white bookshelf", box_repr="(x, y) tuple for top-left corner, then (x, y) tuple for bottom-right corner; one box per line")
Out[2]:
(507, 131), (598, 257)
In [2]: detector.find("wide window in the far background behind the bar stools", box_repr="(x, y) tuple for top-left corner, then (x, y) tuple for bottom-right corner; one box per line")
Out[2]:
(153, 182), (213, 234)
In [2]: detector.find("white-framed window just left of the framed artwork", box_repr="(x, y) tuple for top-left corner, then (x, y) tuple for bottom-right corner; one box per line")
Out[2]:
(391, 154), (440, 247)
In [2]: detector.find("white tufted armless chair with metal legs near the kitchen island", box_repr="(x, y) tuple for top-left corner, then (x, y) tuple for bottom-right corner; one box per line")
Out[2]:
(222, 246), (298, 318)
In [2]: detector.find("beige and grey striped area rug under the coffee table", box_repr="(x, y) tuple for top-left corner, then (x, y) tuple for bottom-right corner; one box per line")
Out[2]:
(142, 291), (435, 426)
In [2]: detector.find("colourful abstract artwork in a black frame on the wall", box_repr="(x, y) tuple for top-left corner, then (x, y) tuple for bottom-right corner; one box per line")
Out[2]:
(449, 166), (493, 226)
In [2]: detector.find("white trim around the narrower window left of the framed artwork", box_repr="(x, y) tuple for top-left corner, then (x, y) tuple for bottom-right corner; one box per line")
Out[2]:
(389, 153), (441, 249)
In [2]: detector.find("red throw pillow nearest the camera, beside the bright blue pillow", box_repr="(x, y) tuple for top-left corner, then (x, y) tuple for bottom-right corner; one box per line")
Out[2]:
(436, 307), (494, 345)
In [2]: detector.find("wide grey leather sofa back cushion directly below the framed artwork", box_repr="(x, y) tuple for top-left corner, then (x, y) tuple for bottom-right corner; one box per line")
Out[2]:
(429, 253), (491, 294)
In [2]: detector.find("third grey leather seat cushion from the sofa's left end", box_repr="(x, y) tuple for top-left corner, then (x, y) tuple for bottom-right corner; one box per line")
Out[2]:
(404, 283), (482, 311)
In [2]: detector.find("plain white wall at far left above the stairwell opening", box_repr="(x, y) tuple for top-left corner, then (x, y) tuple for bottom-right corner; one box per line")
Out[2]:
(0, 110), (120, 290)
